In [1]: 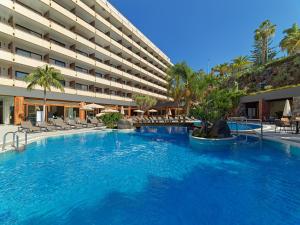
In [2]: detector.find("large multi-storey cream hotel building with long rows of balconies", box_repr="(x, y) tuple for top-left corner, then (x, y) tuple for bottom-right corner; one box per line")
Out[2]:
(0, 0), (171, 124)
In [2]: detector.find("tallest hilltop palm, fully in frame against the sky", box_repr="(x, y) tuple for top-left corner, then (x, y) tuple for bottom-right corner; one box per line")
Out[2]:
(254, 20), (276, 64)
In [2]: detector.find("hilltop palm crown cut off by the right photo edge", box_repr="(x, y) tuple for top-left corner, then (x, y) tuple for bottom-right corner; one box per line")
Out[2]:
(280, 23), (300, 55)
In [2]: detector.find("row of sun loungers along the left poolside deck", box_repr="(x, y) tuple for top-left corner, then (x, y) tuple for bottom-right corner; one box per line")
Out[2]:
(19, 118), (104, 133)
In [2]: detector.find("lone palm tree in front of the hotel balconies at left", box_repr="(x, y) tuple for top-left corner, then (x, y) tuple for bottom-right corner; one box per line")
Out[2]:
(24, 65), (64, 121)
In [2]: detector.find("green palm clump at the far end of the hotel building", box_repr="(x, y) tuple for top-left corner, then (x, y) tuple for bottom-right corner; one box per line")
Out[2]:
(168, 62), (199, 114)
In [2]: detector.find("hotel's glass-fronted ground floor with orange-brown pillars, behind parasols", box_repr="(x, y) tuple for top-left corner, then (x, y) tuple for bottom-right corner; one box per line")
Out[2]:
(0, 94), (178, 125)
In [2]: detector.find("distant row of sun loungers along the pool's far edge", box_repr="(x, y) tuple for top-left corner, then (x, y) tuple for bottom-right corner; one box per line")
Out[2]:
(132, 116), (195, 124)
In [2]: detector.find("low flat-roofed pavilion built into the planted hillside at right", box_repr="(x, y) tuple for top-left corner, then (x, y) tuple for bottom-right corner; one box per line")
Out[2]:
(238, 87), (300, 121)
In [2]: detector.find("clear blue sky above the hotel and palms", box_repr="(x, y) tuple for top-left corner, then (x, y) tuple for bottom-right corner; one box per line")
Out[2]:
(110, 0), (300, 70)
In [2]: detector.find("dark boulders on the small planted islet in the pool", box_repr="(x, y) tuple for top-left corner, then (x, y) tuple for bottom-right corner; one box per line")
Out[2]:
(192, 120), (231, 138)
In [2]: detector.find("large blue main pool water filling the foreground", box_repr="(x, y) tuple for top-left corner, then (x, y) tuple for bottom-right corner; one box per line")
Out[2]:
(0, 127), (300, 225)
